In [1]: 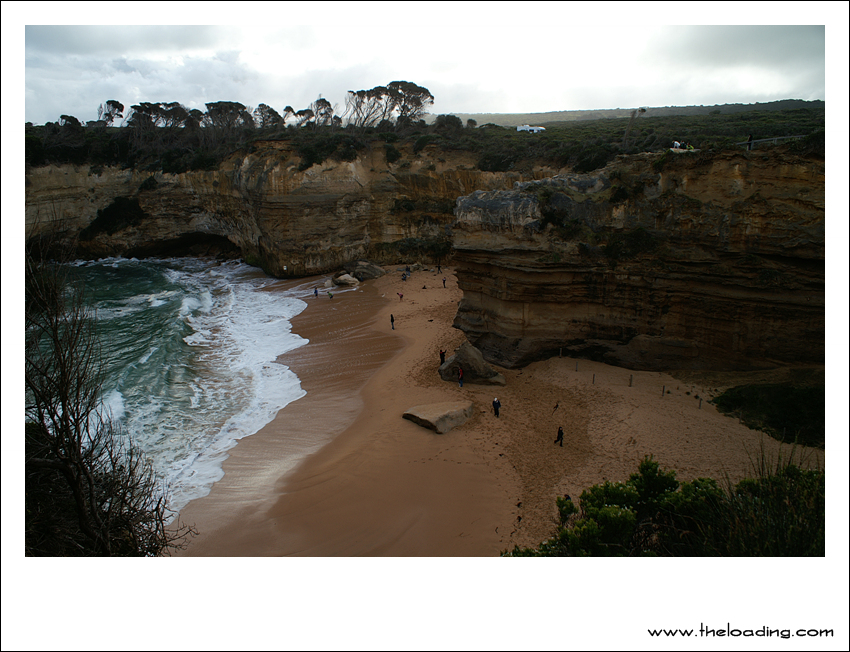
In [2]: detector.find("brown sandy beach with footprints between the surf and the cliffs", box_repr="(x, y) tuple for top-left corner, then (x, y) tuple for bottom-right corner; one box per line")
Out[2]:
(180, 268), (824, 557)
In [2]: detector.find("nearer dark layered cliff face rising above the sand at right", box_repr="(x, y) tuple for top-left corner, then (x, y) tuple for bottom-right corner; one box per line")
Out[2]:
(454, 151), (824, 369)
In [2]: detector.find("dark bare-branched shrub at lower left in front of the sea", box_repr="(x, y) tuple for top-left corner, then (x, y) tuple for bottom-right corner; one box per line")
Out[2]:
(24, 243), (195, 556)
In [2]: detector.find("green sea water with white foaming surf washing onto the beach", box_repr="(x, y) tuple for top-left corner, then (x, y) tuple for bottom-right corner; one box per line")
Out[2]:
(77, 258), (314, 511)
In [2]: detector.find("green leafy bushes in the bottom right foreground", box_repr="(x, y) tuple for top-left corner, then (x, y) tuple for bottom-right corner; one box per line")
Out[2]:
(502, 450), (826, 557)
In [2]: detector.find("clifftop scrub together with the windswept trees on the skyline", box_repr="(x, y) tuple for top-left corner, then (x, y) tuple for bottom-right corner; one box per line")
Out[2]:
(25, 88), (825, 173)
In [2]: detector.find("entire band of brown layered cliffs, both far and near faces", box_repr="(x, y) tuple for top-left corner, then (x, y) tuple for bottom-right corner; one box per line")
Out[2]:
(26, 142), (824, 369)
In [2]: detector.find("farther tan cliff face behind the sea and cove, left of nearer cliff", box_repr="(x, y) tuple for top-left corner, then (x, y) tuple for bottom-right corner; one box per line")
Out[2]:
(26, 142), (557, 276)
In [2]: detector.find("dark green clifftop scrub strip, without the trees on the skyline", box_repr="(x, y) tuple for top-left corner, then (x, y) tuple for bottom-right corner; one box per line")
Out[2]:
(25, 108), (825, 173)
